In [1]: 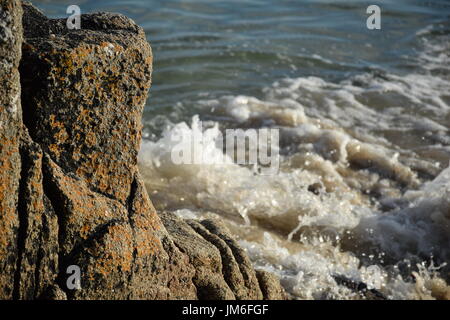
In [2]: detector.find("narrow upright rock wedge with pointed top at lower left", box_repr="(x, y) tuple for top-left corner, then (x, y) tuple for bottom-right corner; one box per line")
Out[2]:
(14, 133), (59, 299)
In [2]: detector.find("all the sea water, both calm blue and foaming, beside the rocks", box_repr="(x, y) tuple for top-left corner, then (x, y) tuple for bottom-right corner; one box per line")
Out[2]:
(33, 0), (450, 299)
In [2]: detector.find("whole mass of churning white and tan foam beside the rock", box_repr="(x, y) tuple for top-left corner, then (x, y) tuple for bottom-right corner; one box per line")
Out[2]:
(139, 30), (450, 299)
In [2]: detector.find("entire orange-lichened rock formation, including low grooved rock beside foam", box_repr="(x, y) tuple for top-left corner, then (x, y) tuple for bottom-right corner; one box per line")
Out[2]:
(0, 1), (284, 299)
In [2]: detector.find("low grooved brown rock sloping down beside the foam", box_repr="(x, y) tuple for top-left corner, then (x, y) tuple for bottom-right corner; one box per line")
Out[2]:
(159, 212), (286, 300)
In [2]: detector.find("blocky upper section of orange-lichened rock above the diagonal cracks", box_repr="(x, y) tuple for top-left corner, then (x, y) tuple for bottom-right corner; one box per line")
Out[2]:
(20, 4), (152, 204)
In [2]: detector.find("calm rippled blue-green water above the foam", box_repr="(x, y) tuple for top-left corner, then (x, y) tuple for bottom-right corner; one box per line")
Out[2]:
(34, 0), (450, 120)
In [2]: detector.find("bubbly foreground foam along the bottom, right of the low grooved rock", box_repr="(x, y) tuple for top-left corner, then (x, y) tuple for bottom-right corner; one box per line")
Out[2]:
(240, 233), (450, 300)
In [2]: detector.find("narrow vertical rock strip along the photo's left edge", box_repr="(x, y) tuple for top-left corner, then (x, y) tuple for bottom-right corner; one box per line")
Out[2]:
(0, 0), (22, 299)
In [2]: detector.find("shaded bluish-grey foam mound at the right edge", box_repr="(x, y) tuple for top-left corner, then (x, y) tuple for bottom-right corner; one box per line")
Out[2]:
(359, 168), (450, 263)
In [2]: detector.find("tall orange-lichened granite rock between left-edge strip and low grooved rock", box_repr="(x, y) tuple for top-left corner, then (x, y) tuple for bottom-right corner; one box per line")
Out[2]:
(17, 3), (196, 299)
